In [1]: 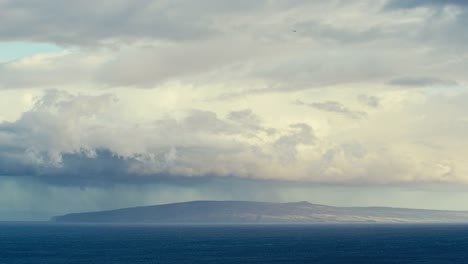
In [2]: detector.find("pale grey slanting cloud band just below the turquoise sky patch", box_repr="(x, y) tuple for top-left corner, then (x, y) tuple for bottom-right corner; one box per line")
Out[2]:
(0, 40), (253, 89)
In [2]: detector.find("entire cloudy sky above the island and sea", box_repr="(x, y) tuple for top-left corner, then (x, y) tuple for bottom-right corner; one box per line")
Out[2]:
(0, 0), (468, 220)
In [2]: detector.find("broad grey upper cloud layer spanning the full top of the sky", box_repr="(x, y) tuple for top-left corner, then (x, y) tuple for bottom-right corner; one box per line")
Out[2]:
(0, 0), (466, 91)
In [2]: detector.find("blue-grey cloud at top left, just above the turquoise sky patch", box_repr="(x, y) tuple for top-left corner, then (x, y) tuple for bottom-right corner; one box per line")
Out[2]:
(0, 0), (308, 46)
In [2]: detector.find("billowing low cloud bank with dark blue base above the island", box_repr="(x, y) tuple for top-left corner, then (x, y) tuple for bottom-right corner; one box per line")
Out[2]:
(0, 90), (468, 186)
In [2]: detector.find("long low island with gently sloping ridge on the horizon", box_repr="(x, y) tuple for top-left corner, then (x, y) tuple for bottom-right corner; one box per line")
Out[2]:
(52, 201), (468, 224)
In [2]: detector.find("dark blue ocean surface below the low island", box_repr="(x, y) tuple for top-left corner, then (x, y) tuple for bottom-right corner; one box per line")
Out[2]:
(0, 223), (468, 264)
